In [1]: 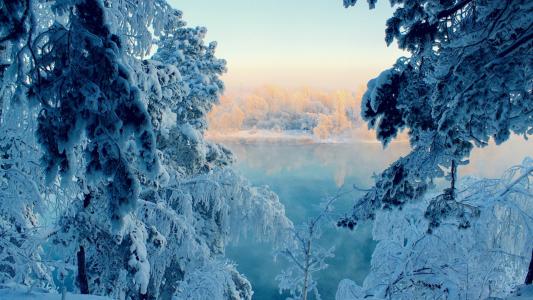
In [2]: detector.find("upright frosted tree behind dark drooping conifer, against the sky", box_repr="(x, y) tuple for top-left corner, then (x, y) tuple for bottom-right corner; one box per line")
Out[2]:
(153, 26), (228, 173)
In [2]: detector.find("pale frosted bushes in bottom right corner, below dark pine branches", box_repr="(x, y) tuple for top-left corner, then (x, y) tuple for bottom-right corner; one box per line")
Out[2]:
(336, 158), (533, 300)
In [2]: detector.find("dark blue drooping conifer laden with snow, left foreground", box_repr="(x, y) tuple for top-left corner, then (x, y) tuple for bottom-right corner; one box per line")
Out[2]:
(17, 0), (164, 293)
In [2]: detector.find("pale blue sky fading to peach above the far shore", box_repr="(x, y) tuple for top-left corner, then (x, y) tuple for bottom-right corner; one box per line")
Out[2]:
(170, 0), (401, 89)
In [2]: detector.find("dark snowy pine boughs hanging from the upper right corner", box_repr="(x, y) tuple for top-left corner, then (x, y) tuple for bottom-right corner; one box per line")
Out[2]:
(340, 0), (533, 227)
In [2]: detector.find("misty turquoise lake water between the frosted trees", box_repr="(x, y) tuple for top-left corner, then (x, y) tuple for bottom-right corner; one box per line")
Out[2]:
(218, 138), (533, 300)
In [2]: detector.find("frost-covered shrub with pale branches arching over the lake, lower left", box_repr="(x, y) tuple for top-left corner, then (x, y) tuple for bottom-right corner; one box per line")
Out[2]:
(50, 163), (292, 299)
